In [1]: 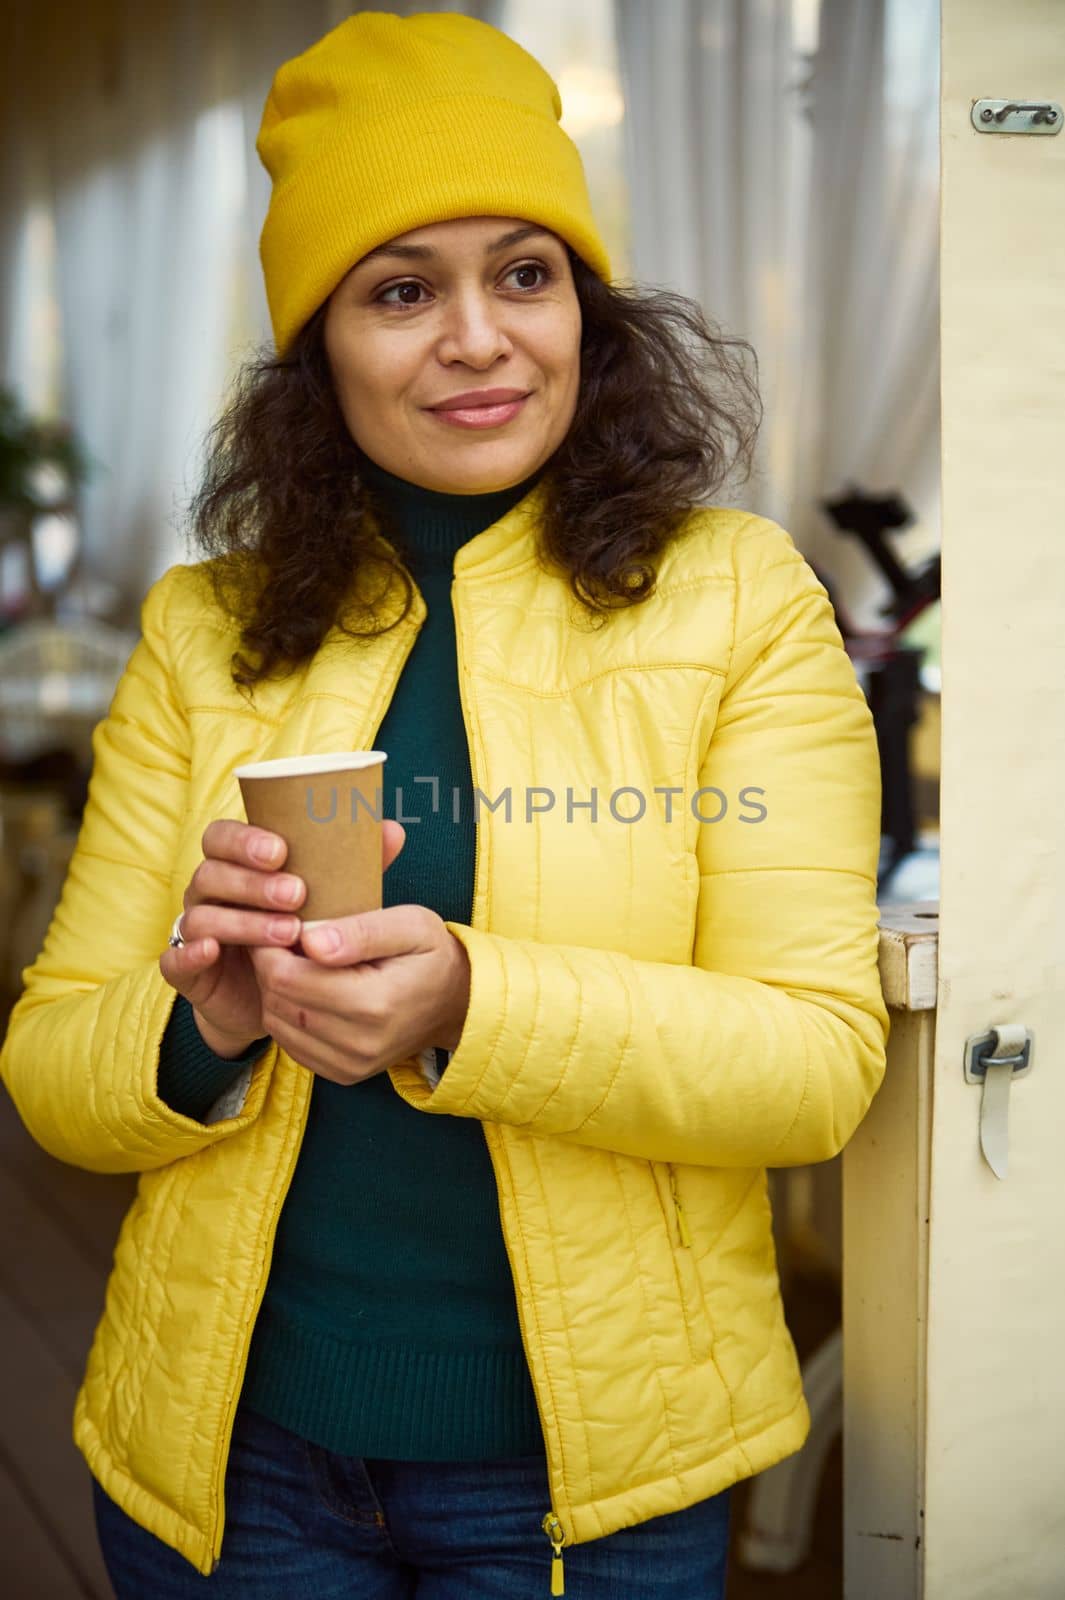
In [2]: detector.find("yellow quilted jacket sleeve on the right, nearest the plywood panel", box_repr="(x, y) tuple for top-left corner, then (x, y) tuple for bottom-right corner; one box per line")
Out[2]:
(392, 518), (889, 1166)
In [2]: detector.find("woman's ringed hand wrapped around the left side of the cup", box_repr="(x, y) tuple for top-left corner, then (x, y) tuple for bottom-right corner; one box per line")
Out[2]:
(158, 818), (406, 1056)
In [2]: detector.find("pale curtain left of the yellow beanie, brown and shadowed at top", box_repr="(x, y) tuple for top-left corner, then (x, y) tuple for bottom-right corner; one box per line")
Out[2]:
(0, 0), (494, 621)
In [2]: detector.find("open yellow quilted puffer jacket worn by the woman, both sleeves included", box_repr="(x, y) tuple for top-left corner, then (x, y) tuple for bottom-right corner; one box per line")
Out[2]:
(0, 490), (888, 1573)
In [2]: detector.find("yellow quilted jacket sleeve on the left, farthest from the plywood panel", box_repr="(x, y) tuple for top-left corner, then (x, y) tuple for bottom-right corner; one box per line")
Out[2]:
(0, 566), (278, 1173)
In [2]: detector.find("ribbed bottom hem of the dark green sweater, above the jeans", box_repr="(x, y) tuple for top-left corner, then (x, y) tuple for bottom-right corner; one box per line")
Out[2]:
(241, 1306), (544, 1461)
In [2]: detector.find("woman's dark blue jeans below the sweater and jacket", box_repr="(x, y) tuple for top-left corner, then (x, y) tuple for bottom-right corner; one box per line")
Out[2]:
(93, 1406), (729, 1600)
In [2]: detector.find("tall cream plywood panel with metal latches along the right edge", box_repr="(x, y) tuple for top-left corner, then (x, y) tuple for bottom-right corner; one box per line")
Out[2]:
(924, 0), (1065, 1600)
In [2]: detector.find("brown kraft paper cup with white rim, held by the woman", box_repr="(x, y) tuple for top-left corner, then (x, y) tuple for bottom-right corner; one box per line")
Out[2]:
(233, 750), (389, 928)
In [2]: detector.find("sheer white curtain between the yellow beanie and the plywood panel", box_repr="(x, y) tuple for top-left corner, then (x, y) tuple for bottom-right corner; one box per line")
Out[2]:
(616, 0), (939, 626)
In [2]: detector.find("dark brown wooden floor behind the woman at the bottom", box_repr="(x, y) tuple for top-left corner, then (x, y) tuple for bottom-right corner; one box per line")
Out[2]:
(0, 1062), (843, 1600)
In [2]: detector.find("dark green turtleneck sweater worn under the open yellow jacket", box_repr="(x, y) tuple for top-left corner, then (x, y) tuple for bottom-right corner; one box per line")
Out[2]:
(158, 467), (544, 1461)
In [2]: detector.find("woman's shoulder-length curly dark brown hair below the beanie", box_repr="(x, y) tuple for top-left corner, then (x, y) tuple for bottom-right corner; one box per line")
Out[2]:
(190, 246), (761, 686)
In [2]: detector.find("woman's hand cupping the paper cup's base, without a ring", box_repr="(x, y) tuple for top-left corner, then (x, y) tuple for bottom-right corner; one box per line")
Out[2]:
(249, 906), (470, 1083)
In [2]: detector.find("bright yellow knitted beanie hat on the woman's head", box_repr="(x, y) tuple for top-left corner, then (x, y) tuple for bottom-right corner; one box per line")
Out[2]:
(256, 11), (611, 355)
